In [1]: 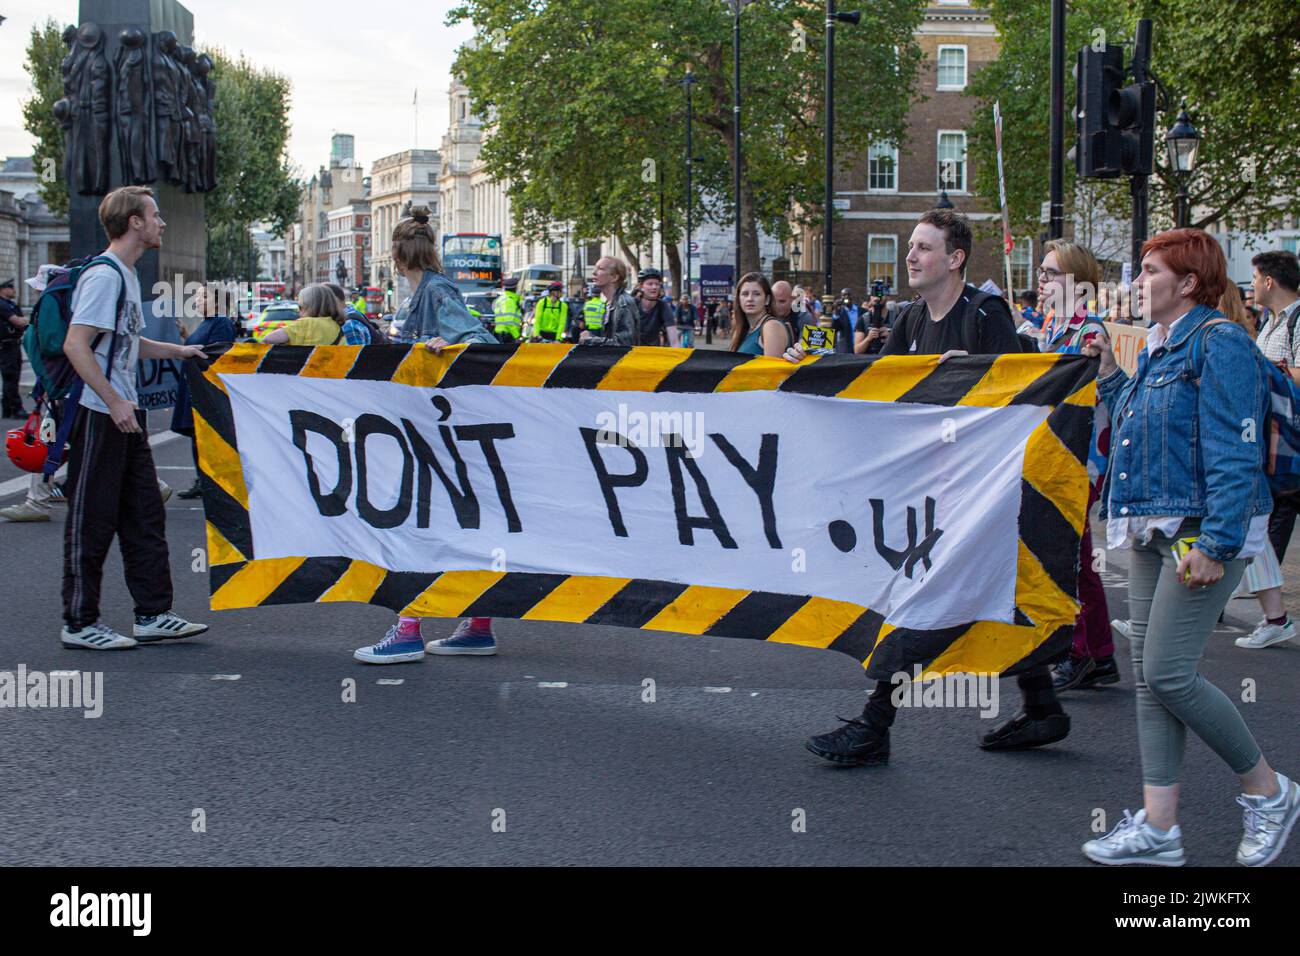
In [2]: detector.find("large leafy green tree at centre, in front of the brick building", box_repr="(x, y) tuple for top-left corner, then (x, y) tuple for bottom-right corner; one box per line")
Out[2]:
(447, 0), (923, 274)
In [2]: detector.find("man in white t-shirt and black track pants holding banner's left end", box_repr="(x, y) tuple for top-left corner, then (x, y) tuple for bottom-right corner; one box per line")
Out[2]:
(62, 186), (208, 650)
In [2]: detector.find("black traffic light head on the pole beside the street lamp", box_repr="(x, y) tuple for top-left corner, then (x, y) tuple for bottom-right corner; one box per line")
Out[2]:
(1074, 46), (1156, 179)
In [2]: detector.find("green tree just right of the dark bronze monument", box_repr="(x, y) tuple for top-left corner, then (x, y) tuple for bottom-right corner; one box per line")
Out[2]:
(203, 49), (302, 281)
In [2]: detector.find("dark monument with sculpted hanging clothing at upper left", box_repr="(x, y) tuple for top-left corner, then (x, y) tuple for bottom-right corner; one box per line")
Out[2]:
(53, 0), (217, 300)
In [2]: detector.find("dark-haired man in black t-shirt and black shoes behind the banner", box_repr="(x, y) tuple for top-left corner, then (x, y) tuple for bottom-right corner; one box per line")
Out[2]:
(785, 209), (1070, 765)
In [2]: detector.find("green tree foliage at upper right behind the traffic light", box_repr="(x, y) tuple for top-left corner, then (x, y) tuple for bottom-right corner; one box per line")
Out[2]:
(971, 0), (1300, 259)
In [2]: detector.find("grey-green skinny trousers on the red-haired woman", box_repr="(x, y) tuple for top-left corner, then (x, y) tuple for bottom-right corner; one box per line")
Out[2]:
(1128, 519), (1261, 787)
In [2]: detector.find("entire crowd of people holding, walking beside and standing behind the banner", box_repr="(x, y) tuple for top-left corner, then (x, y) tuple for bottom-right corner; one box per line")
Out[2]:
(0, 187), (1300, 865)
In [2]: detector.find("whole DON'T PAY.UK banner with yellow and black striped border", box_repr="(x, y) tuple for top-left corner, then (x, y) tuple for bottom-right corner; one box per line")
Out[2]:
(190, 343), (1096, 676)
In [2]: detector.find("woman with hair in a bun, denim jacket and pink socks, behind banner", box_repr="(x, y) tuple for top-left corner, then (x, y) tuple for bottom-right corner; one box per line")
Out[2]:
(353, 206), (498, 663)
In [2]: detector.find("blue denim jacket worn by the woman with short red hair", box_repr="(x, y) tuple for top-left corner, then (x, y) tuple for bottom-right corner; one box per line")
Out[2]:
(1097, 306), (1273, 561)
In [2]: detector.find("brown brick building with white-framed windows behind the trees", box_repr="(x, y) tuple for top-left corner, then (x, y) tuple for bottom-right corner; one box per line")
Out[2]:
(796, 0), (1034, 298)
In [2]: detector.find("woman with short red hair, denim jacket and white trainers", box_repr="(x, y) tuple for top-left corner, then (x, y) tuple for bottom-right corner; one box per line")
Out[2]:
(1083, 229), (1300, 866)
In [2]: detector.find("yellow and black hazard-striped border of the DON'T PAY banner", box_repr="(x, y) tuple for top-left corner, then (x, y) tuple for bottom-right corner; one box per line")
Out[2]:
(190, 343), (1096, 679)
